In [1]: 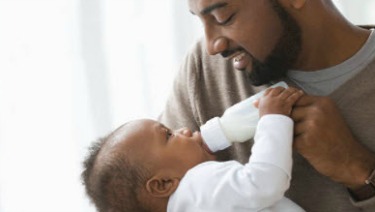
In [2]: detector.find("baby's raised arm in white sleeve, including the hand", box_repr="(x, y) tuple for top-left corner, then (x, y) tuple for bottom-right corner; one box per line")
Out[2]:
(246, 87), (303, 208)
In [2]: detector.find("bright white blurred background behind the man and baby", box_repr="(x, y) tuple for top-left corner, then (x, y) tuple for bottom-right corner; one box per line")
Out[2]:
(0, 0), (375, 212)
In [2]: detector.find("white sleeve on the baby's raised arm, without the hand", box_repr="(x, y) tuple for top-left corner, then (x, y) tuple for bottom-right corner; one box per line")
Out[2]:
(244, 114), (293, 208)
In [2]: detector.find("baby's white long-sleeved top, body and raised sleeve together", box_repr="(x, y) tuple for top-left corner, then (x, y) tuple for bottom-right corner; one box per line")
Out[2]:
(168, 115), (302, 212)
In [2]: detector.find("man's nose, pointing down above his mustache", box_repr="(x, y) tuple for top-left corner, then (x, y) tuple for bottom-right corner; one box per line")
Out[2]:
(205, 28), (229, 55)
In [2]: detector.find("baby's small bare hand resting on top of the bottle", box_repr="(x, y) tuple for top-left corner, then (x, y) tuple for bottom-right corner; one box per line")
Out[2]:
(254, 87), (303, 117)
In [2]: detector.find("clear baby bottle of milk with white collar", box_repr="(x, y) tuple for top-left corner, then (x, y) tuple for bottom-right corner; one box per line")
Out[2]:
(200, 81), (288, 152)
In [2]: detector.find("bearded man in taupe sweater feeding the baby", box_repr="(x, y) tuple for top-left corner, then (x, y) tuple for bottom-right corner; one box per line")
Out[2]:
(160, 0), (375, 212)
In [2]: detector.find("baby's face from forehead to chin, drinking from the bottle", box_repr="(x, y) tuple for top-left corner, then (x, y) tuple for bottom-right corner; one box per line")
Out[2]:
(114, 120), (215, 177)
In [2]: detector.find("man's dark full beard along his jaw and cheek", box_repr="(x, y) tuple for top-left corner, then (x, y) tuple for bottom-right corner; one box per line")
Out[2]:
(249, 0), (302, 86)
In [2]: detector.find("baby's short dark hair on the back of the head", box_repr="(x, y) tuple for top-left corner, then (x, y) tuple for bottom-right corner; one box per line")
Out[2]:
(81, 135), (148, 212)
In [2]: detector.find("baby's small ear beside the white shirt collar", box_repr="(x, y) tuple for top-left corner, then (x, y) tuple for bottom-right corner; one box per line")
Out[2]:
(146, 176), (180, 197)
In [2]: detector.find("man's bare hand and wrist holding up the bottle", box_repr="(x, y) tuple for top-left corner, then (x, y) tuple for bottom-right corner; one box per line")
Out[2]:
(291, 95), (375, 189)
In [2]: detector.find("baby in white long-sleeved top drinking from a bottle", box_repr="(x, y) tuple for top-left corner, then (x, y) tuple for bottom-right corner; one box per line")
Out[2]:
(82, 87), (304, 212)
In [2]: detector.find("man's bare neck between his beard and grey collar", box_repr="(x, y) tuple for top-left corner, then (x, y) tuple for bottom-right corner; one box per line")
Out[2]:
(293, 2), (370, 71)
